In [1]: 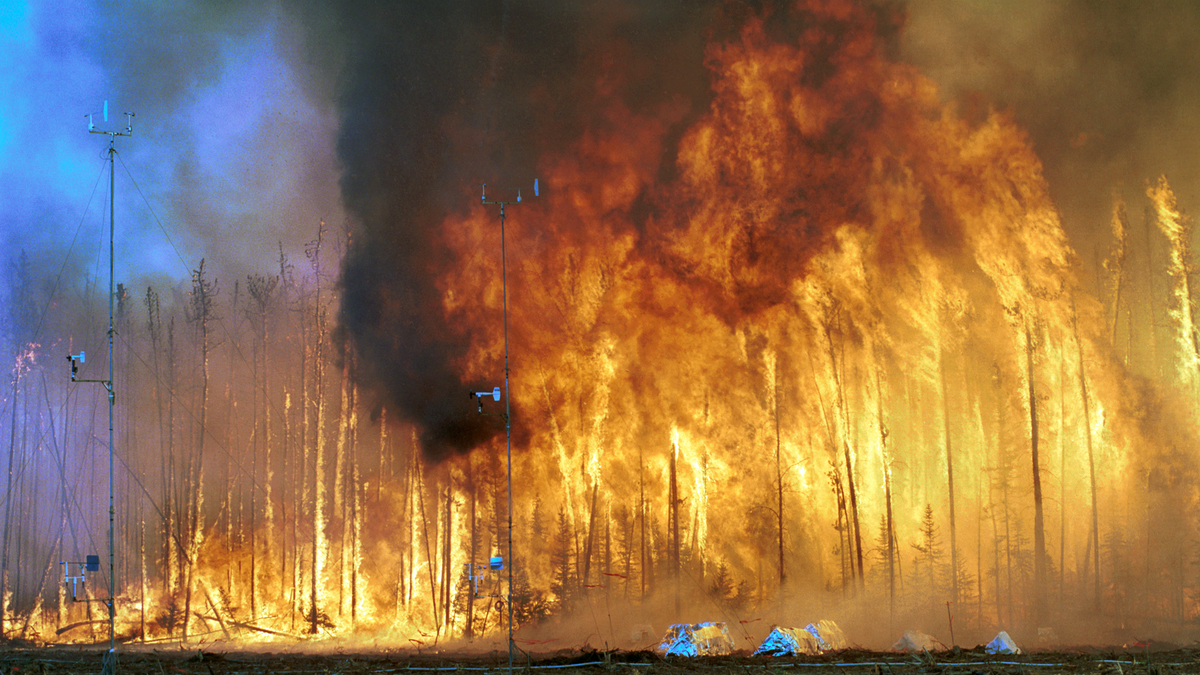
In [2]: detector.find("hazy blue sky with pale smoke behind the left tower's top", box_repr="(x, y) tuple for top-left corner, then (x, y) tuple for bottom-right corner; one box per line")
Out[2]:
(0, 0), (342, 293)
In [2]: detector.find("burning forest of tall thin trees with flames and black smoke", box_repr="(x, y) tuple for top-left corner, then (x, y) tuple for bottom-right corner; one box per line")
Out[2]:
(7, 0), (1200, 649)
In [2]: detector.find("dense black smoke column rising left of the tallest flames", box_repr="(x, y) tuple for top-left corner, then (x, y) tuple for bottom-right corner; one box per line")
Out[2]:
(336, 1), (713, 456)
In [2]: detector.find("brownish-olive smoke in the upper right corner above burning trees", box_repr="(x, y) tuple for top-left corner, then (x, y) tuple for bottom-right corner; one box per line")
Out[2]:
(901, 0), (1200, 252)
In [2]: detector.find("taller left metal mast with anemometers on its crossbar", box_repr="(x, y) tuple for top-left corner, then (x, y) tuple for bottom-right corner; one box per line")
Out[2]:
(77, 101), (134, 675)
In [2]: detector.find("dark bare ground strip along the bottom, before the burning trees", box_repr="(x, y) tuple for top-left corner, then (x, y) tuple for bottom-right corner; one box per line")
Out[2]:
(0, 645), (1200, 675)
